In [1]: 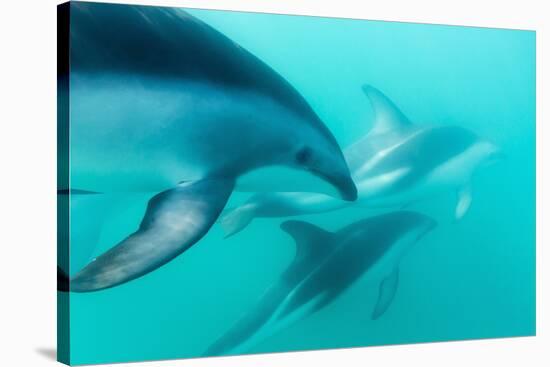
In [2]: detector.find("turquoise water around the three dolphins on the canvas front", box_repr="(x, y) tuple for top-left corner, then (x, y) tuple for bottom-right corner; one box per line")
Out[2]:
(70, 5), (535, 364)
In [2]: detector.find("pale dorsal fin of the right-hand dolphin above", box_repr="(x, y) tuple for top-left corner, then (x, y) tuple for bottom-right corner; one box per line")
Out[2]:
(363, 84), (411, 134)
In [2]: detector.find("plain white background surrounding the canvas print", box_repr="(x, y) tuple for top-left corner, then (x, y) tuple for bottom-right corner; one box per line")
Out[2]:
(0, 0), (550, 367)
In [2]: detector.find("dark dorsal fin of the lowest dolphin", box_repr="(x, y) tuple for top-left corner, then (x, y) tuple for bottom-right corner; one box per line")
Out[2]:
(281, 220), (334, 259)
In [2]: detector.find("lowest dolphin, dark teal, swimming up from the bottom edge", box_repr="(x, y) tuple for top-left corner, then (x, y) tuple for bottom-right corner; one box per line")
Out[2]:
(205, 211), (436, 356)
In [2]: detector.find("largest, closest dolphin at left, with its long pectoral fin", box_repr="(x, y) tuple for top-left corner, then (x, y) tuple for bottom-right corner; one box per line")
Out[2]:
(61, 2), (357, 292)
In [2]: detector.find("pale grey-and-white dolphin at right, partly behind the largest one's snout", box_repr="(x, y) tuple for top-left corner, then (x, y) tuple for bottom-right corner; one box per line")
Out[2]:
(221, 85), (501, 236)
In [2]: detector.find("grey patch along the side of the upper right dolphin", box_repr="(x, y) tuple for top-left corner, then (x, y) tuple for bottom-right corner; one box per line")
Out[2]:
(368, 126), (477, 194)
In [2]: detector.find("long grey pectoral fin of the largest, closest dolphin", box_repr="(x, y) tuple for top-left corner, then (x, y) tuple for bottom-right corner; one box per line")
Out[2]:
(70, 179), (234, 292)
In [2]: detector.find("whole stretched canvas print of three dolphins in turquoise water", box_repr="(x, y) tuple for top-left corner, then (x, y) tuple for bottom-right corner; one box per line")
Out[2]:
(57, 2), (535, 365)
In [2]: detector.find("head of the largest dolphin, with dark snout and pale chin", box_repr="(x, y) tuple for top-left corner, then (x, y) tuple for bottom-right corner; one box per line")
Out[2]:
(237, 112), (357, 201)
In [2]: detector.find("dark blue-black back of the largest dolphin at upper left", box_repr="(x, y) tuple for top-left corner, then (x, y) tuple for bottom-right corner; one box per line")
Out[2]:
(67, 2), (331, 130)
